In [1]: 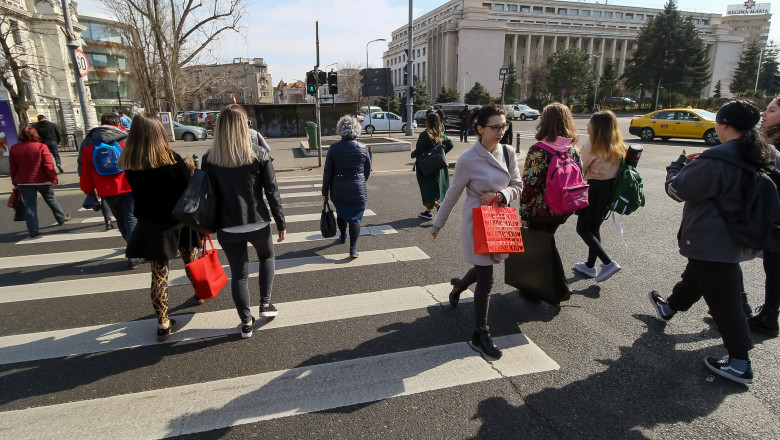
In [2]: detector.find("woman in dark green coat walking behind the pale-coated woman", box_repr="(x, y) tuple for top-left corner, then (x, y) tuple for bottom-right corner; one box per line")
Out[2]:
(412, 113), (454, 220)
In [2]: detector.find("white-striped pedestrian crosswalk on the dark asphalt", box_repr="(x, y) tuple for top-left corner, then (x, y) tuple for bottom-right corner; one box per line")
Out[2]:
(0, 171), (559, 440)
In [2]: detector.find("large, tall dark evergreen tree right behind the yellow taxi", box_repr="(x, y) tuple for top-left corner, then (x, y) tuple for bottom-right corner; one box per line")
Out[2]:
(623, 0), (710, 105)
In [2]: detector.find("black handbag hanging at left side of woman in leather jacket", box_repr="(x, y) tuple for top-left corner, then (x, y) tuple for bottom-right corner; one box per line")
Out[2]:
(173, 170), (217, 235)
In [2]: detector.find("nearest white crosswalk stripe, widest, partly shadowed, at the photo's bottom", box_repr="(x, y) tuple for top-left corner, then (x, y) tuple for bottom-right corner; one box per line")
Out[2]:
(0, 333), (560, 440)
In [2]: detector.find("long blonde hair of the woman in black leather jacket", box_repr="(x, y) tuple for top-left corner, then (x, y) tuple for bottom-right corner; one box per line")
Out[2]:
(209, 104), (256, 168)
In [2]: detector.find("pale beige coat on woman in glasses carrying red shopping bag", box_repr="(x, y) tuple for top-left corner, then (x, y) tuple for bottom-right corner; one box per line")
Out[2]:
(433, 141), (523, 266)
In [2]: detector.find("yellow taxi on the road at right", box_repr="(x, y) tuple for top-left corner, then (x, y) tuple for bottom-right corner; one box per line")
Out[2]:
(628, 108), (720, 145)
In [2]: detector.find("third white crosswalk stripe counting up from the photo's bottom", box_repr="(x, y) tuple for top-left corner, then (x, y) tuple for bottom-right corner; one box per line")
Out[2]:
(0, 246), (430, 304)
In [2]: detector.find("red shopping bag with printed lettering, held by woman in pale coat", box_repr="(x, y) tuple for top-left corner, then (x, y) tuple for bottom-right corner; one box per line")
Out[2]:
(472, 200), (524, 254)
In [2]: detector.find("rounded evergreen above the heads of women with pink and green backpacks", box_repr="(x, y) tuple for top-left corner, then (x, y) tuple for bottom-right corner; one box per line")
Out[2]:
(547, 48), (596, 105)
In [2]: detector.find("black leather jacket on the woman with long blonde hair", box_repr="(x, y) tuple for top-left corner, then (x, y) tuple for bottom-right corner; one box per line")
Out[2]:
(202, 148), (287, 231)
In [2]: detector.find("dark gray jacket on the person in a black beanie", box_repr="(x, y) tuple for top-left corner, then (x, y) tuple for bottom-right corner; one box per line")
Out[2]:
(666, 140), (760, 263)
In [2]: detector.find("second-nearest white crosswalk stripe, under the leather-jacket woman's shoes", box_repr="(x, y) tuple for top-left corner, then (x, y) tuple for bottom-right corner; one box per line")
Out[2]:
(0, 283), (473, 365)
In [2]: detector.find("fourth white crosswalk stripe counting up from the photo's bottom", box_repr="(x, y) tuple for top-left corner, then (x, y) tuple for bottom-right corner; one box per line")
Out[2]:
(0, 225), (398, 270)
